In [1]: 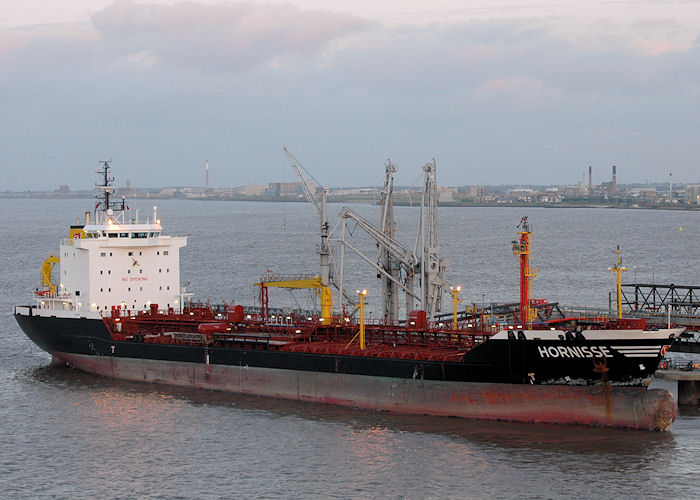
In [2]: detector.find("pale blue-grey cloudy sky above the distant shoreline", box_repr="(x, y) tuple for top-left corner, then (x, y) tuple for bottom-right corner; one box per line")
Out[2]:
(0, 0), (700, 191)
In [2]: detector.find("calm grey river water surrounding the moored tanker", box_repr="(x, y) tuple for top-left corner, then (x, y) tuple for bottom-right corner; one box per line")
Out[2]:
(0, 199), (700, 498)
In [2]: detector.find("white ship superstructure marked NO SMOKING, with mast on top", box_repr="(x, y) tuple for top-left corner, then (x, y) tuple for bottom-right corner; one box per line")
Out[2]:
(37, 165), (187, 316)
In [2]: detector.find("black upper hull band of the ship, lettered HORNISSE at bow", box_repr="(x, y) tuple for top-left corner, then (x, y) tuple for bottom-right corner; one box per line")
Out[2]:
(15, 309), (671, 387)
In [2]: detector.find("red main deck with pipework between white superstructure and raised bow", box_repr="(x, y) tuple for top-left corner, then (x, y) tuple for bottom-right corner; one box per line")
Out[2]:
(104, 306), (495, 361)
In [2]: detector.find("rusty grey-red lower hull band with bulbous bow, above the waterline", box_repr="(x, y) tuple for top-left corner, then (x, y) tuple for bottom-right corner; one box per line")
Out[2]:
(53, 353), (677, 431)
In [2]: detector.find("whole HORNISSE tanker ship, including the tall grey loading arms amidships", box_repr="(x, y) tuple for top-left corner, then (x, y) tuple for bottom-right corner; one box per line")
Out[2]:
(14, 162), (683, 431)
